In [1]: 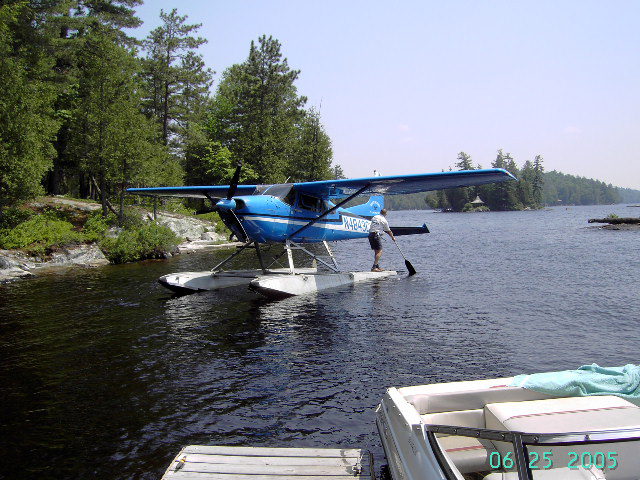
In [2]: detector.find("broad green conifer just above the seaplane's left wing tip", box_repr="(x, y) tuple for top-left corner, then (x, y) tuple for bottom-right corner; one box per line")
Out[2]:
(71, 27), (180, 216)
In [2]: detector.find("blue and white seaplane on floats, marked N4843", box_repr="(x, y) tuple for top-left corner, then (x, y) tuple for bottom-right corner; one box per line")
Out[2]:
(127, 164), (515, 298)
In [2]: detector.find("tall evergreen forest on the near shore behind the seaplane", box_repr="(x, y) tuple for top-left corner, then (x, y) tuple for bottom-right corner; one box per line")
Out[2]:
(0, 0), (341, 215)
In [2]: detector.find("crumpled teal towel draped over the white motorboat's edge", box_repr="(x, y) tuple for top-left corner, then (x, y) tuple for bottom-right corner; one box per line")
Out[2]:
(510, 363), (640, 404)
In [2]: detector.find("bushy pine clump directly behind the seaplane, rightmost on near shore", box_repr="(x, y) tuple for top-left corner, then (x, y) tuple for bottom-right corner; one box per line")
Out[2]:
(204, 35), (344, 183)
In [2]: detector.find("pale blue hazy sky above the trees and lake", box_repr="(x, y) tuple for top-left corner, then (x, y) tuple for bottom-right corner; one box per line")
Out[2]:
(127, 0), (640, 189)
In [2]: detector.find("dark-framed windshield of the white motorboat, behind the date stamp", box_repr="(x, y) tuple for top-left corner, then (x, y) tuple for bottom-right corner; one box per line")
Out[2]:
(423, 424), (640, 480)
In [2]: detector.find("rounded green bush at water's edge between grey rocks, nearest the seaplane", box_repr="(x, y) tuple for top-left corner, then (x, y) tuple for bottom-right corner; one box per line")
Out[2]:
(100, 222), (179, 263)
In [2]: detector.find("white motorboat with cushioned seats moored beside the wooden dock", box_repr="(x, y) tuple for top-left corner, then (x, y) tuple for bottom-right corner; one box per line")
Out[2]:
(376, 365), (640, 480)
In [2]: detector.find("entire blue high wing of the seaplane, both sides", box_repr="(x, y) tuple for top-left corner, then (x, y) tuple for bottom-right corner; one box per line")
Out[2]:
(127, 168), (516, 199)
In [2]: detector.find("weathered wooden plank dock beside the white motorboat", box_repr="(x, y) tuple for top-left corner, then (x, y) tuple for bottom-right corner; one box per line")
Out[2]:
(162, 445), (375, 480)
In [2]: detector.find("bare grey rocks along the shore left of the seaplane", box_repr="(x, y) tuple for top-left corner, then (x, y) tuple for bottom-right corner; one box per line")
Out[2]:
(0, 197), (237, 284)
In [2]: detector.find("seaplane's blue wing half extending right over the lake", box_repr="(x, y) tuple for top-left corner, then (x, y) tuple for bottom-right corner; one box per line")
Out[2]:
(294, 168), (517, 198)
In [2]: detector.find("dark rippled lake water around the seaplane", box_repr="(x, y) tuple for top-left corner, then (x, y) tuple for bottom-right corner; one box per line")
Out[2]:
(0, 205), (640, 479)
